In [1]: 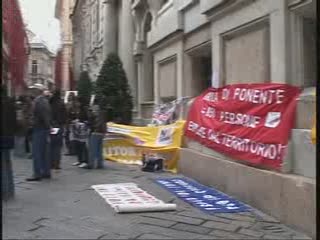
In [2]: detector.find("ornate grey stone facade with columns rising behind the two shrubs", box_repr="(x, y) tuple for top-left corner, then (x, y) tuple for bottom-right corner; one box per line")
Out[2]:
(71, 0), (137, 115)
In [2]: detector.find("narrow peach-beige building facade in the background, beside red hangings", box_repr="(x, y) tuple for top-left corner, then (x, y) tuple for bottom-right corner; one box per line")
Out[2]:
(55, 0), (74, 91)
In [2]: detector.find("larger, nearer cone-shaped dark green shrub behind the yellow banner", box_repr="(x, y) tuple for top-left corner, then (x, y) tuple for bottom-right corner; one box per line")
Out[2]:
(96, 53), (133, 124)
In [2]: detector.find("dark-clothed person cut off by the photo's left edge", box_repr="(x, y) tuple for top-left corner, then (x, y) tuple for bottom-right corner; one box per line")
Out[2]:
(0, 86), (17, 200)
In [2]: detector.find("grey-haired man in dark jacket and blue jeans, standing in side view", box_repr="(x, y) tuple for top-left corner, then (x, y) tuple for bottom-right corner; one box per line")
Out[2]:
(27, 84), (51, 181)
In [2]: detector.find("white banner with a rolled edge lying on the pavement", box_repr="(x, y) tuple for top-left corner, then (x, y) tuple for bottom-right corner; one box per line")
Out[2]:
(91, 183), (176, 212)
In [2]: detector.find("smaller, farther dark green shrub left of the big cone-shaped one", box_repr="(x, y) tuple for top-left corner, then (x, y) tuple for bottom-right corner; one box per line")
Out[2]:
(77, 71), (93, 107)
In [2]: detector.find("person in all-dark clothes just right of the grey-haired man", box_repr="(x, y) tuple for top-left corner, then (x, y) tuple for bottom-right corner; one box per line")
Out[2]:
(50, 89), (66, 169)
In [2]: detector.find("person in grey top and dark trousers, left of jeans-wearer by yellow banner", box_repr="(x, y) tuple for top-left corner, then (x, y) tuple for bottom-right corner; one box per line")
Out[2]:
(72, 110), (90, 168)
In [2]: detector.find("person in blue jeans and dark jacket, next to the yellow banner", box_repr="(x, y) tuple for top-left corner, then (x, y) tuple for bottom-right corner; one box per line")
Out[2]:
(88, 105), (107, 169)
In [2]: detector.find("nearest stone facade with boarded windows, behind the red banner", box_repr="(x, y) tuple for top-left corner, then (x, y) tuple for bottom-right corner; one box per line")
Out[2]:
(138, 0), (317, 237)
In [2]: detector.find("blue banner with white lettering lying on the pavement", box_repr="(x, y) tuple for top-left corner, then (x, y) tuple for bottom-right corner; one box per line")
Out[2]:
(155, 178), (250, 213)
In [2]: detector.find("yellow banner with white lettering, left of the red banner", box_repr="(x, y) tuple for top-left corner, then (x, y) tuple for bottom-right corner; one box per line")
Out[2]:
(104, 121), (185, 172)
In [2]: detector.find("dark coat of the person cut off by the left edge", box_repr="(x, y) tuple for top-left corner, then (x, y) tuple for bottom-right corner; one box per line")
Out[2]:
(0, 97), (17, 149)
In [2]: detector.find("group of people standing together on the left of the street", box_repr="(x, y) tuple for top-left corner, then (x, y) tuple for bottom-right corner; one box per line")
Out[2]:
(1, 84), (106, 200)
